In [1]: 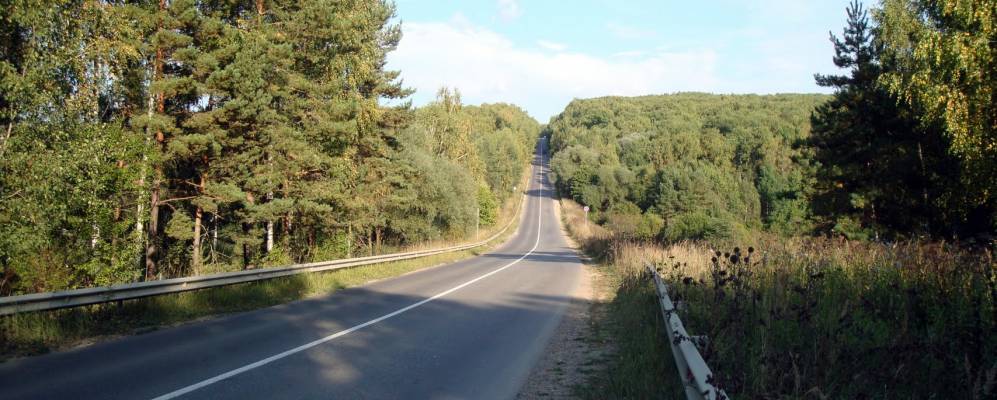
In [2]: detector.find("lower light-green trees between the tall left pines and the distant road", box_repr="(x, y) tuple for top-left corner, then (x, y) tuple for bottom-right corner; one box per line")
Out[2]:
(393, 89), (540, 240)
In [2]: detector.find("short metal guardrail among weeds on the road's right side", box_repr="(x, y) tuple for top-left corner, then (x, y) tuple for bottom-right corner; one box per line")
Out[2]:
(647, 265), (730, 400)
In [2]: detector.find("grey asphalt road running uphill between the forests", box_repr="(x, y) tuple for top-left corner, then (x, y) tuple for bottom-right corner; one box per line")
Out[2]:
(0, 138), (581, 399)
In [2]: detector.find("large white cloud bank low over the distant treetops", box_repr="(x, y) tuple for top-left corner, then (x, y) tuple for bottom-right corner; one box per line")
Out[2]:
(388, 22), (720, 121)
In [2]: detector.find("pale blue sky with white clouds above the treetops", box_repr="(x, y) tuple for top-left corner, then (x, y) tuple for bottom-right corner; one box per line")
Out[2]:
(388, 0), (850, 123)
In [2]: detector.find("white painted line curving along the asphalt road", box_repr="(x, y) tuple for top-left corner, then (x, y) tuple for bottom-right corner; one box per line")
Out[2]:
(153, 139), (546, 400)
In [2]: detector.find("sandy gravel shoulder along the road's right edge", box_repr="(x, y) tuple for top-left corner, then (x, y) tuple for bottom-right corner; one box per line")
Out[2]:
(517, 202), (611, 400)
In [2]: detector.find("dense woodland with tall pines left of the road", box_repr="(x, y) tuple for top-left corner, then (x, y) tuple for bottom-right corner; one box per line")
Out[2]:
(0, 0), (540, 295)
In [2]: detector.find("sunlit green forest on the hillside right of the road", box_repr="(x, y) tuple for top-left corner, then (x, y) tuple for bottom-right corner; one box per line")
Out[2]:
(547, 93), (827, 240)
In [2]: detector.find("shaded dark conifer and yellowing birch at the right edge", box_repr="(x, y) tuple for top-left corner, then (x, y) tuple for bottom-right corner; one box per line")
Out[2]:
(809, 1), (997, 238)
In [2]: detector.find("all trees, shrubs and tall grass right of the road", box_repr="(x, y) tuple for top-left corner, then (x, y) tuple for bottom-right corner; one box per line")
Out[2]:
(547, 0), (997, 399)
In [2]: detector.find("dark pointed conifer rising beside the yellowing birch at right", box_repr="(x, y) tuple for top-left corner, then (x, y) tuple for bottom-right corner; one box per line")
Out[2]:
(810, 2), (959, 237)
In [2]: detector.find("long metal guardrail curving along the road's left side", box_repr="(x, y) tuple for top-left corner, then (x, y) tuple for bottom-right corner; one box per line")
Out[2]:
(0, 194), (525, 316)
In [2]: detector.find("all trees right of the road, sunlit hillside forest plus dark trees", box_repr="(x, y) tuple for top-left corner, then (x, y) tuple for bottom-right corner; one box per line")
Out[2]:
(547, 0), (997, 241)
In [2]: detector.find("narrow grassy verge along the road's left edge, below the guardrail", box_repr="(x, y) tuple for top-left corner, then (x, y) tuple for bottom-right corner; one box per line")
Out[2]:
(0, 167), (529, 361)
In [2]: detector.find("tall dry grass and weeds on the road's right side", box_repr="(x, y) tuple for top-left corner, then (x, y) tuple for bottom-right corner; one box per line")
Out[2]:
(564, 198), (997, 399)
